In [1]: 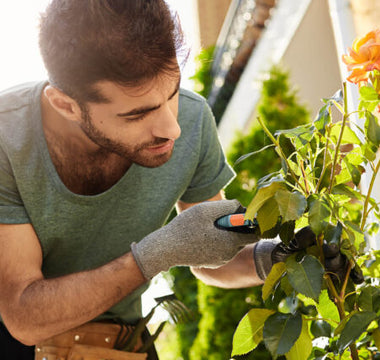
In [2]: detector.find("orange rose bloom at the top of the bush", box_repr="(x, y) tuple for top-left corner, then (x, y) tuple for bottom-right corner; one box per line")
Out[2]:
(342, 29), (380, 84)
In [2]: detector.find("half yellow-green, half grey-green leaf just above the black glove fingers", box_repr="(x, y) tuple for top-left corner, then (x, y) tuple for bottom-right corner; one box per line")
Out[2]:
(274, 190), (307, 222)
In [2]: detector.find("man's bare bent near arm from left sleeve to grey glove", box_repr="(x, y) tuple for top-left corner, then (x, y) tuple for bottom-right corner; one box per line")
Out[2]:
(0, 224), (146, 345)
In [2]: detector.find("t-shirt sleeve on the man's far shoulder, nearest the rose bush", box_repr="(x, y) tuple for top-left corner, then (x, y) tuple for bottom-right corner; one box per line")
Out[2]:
(181, 103), (235, 203)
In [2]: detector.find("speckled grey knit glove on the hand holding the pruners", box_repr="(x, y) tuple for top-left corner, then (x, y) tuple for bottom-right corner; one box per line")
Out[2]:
(131, 200), (260, 279)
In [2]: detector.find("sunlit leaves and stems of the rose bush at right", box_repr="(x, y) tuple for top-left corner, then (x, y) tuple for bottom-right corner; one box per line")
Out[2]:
(233, 70), (380, 360)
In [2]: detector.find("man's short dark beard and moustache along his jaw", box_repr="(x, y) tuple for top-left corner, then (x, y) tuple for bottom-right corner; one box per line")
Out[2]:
(80, 107), (173, 168)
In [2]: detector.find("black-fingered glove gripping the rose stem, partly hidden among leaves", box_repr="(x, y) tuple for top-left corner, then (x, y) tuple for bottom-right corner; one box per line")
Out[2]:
(254, 226), (364, 284)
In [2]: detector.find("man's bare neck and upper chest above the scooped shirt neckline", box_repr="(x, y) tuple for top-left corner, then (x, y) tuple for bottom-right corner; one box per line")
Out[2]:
(41, 89), (131, 195)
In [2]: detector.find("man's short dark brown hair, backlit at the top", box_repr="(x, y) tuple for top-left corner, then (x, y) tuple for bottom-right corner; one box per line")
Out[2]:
(39, 0), (184, 103)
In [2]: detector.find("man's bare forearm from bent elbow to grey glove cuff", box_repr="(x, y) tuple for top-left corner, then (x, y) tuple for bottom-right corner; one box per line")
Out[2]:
(2, 253), (146, 345)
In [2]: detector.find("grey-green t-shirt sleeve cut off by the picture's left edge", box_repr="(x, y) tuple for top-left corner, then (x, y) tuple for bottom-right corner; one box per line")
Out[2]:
(0, 146), (30, 224)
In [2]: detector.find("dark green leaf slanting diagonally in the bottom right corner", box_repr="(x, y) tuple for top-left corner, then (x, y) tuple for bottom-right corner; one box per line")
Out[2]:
(336, 311), (377, 354)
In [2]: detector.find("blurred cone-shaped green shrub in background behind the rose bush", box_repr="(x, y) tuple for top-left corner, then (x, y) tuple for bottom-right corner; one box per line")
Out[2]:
(226, 66), (310, 206)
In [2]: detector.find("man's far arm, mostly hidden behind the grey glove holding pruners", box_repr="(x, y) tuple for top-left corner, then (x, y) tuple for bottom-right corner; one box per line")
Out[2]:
(177, 192), (263, 289)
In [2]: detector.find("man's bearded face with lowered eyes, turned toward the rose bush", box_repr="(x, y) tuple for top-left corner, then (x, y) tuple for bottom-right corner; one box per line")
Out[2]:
(80, 75), (181, 167)
